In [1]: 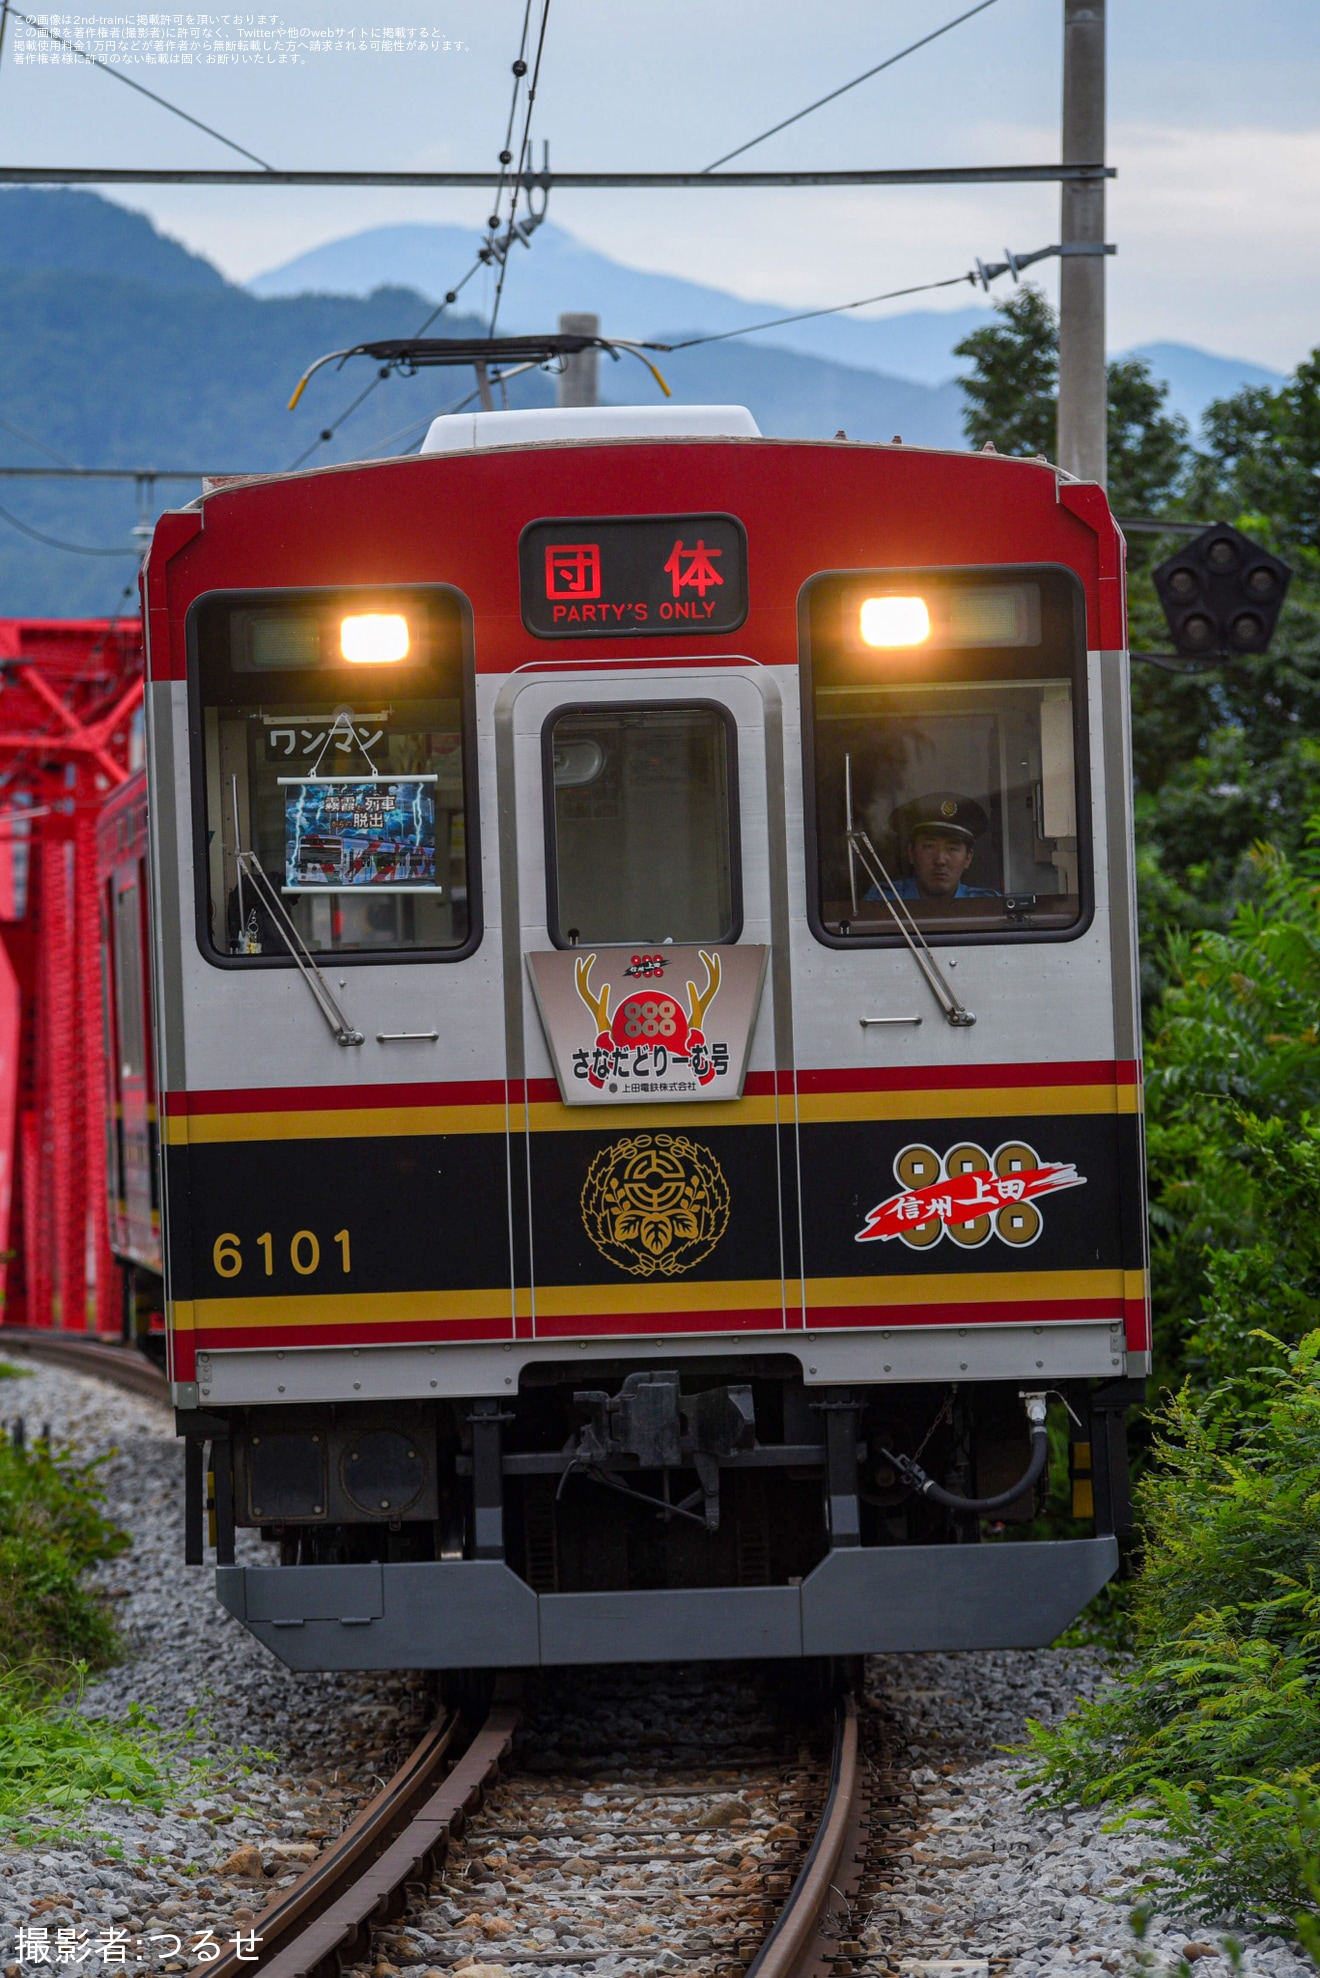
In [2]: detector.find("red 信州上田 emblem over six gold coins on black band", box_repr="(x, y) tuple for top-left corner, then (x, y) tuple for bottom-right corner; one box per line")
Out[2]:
(855, 1139), (1086, 1250)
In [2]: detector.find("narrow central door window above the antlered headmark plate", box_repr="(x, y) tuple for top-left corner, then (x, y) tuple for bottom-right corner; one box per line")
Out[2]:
(544, 702), (740, 947)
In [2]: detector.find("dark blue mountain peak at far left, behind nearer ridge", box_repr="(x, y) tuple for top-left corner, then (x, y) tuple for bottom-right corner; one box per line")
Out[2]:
(0, 186), (226, 293)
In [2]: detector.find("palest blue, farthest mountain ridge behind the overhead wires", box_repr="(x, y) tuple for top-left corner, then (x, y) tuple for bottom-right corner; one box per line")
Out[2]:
(247, 222), (986, 386)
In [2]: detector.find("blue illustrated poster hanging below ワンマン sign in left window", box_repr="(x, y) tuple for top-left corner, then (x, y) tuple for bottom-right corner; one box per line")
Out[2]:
(279, 775), (435, 892)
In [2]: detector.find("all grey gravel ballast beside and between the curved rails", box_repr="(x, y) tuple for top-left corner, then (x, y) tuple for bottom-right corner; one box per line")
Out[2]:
(0, 1365), (1312, 1978)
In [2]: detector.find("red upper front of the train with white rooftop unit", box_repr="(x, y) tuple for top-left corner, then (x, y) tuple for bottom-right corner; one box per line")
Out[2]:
(146, 405), (1126, 678)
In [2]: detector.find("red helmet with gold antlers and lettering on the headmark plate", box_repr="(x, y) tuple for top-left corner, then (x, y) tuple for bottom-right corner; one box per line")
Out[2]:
(574, 947), (728, 1090)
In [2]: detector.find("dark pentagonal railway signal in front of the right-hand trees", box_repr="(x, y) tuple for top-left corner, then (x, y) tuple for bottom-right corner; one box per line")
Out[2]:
(1154, 522), (1292, 659)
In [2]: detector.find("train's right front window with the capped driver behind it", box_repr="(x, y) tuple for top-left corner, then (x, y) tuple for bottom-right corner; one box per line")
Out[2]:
(803, 570), (1088, 942)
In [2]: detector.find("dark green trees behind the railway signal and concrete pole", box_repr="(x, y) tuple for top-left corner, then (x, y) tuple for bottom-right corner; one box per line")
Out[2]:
(958, 289), (1320, 1004)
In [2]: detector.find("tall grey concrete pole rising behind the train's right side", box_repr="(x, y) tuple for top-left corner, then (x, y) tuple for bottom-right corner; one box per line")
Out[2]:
(1059, 0), (1108, 485)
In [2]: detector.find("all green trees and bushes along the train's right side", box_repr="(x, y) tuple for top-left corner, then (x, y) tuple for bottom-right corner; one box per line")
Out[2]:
(962, 291), (1320, 1956)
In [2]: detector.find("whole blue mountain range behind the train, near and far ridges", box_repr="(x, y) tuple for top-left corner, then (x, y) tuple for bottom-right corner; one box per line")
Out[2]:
(0, 188), (1298, 617)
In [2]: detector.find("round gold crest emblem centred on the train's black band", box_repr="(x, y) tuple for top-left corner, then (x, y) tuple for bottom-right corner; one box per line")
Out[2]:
(582, 1133), (728, 1278)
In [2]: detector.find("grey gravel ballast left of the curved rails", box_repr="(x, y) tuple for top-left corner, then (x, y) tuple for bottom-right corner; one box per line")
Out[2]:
(0, 1361), (431, 1978)
